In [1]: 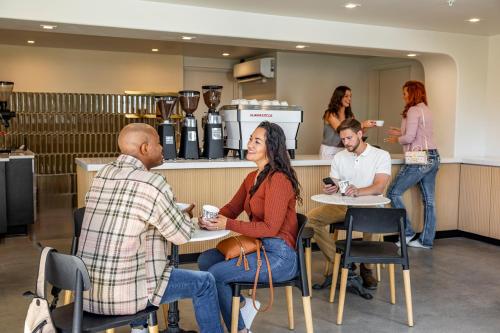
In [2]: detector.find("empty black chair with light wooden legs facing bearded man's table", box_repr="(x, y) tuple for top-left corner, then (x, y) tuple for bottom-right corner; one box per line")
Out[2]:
(334, 208), (413, 326)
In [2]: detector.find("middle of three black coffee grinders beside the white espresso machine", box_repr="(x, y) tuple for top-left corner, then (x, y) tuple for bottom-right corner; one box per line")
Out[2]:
(179, 90), (200, 160)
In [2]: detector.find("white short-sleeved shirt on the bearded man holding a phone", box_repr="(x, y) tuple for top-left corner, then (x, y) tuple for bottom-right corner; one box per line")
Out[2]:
(330, 144), (391, 188)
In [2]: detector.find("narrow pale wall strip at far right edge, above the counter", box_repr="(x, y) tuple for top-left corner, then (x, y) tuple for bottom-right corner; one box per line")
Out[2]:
(484, 35), (500, 156)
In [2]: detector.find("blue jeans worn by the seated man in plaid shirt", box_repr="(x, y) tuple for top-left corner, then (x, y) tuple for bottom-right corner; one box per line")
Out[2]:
(131, 268), (224, 333)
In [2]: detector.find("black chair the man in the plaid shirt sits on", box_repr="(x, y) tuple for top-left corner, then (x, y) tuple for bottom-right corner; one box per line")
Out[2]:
(45, 251), (158, 333)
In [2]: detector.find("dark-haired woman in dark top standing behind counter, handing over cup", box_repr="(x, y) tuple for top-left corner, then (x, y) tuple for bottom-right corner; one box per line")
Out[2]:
(319, 86), (375, 160)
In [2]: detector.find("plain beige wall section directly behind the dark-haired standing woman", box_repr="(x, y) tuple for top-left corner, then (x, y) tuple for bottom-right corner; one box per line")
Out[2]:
(276, 52), (368, 154)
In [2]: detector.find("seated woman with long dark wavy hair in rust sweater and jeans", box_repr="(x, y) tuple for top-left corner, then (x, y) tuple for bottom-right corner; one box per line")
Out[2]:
(198, 121), (301, 333)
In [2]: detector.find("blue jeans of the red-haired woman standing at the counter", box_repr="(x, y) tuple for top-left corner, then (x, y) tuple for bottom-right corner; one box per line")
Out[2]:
(387, 149), (440, 247)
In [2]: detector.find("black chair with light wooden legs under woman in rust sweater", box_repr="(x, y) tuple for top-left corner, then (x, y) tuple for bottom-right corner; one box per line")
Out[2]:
(230, 214), (314, 333)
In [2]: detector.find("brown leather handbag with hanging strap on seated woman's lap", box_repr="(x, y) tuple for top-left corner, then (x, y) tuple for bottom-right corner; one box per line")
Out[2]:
(217, 235), (274, 312)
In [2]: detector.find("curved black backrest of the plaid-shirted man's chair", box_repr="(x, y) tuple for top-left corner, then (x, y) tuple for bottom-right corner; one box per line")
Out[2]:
(45, 251), (90, 291)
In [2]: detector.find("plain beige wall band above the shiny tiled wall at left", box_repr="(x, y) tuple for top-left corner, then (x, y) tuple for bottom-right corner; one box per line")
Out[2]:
(0, 45), (183, 94)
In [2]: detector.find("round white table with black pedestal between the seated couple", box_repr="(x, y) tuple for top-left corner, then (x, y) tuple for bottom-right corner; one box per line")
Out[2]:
(167, 218), (231, 333)
